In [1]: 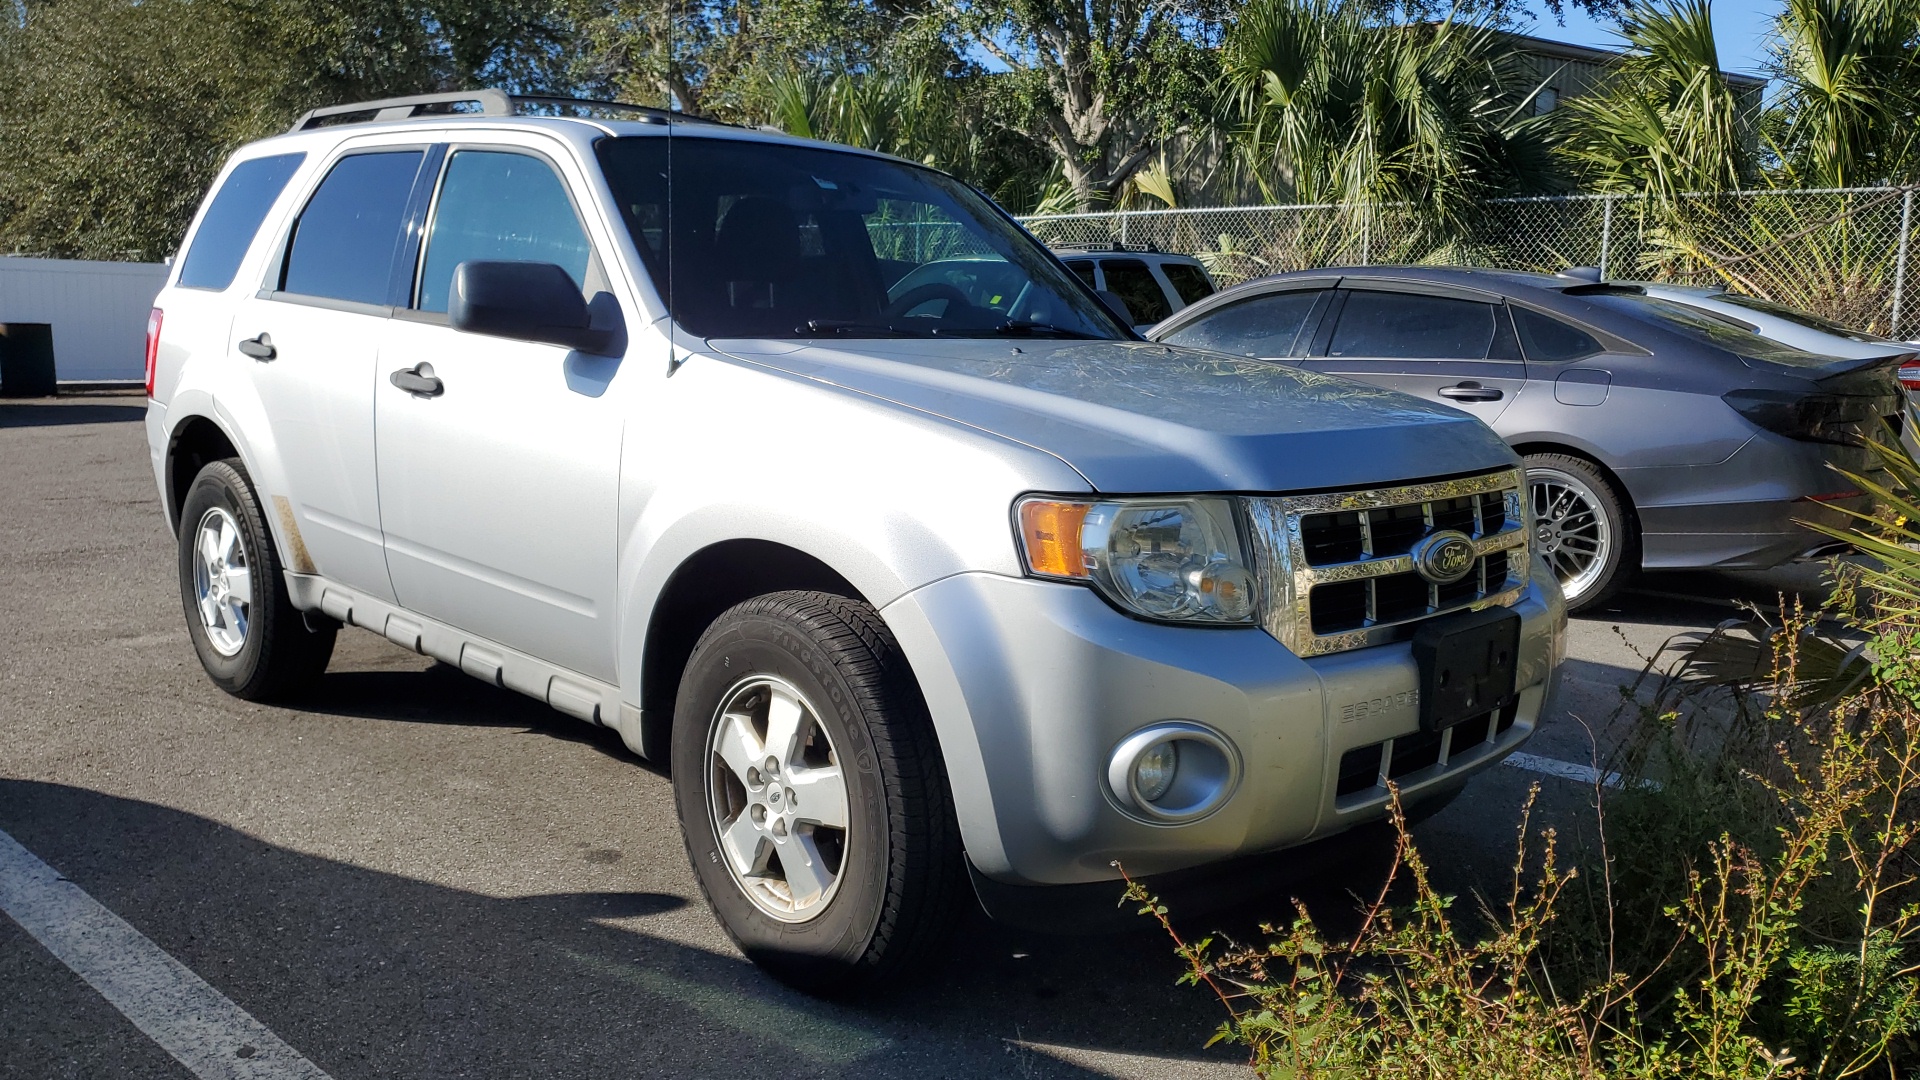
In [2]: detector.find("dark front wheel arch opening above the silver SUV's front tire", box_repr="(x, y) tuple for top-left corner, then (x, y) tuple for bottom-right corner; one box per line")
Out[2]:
(637, 538), (872, 765)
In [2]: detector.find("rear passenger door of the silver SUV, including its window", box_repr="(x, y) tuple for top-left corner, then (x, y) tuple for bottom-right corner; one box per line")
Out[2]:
(228, 148), (426, 600)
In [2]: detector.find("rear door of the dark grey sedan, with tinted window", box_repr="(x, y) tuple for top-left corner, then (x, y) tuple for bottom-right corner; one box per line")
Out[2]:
(1304, 284), (1526, 425)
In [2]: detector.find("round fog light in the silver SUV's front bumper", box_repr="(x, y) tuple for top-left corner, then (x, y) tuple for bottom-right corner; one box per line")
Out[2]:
(1106, 721), (1240, 824)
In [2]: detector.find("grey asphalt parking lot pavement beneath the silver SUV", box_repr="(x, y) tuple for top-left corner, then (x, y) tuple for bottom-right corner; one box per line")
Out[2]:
(0, 396), (1816, 1080)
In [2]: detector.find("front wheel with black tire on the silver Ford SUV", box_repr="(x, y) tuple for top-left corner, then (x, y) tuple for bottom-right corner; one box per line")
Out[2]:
(672, 592), (964, 994)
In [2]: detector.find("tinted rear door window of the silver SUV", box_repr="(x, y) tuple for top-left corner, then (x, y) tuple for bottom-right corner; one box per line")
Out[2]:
(280, 150), (424, 304)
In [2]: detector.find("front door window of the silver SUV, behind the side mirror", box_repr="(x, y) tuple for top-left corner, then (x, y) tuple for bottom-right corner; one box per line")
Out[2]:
(415, 150), (593, 311)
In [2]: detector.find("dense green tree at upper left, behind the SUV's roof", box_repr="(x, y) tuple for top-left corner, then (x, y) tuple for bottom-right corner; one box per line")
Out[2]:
(0, 0), (564, 259)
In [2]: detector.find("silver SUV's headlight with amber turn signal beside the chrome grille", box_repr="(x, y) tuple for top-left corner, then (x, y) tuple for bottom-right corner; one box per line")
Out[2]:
(1016, 498), (1256, 626)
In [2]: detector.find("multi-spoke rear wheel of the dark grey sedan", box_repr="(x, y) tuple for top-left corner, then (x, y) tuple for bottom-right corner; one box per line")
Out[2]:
(1523, 454), (1640, 613)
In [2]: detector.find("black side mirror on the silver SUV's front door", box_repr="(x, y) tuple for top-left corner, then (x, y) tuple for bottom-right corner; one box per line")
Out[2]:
(447, 259), (620, 354)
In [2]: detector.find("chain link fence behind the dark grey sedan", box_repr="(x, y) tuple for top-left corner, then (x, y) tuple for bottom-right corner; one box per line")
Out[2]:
(1021, 188), (1920, 338)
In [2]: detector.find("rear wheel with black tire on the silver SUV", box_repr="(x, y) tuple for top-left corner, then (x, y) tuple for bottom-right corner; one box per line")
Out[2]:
(179, 457), (338, 701)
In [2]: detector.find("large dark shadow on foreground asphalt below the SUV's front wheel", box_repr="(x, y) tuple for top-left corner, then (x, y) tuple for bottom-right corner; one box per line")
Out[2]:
(0, 780), (1233, 1080)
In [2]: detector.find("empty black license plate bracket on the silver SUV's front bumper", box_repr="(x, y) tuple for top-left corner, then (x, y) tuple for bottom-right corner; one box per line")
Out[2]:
(1413, 607), (1521, 732)
